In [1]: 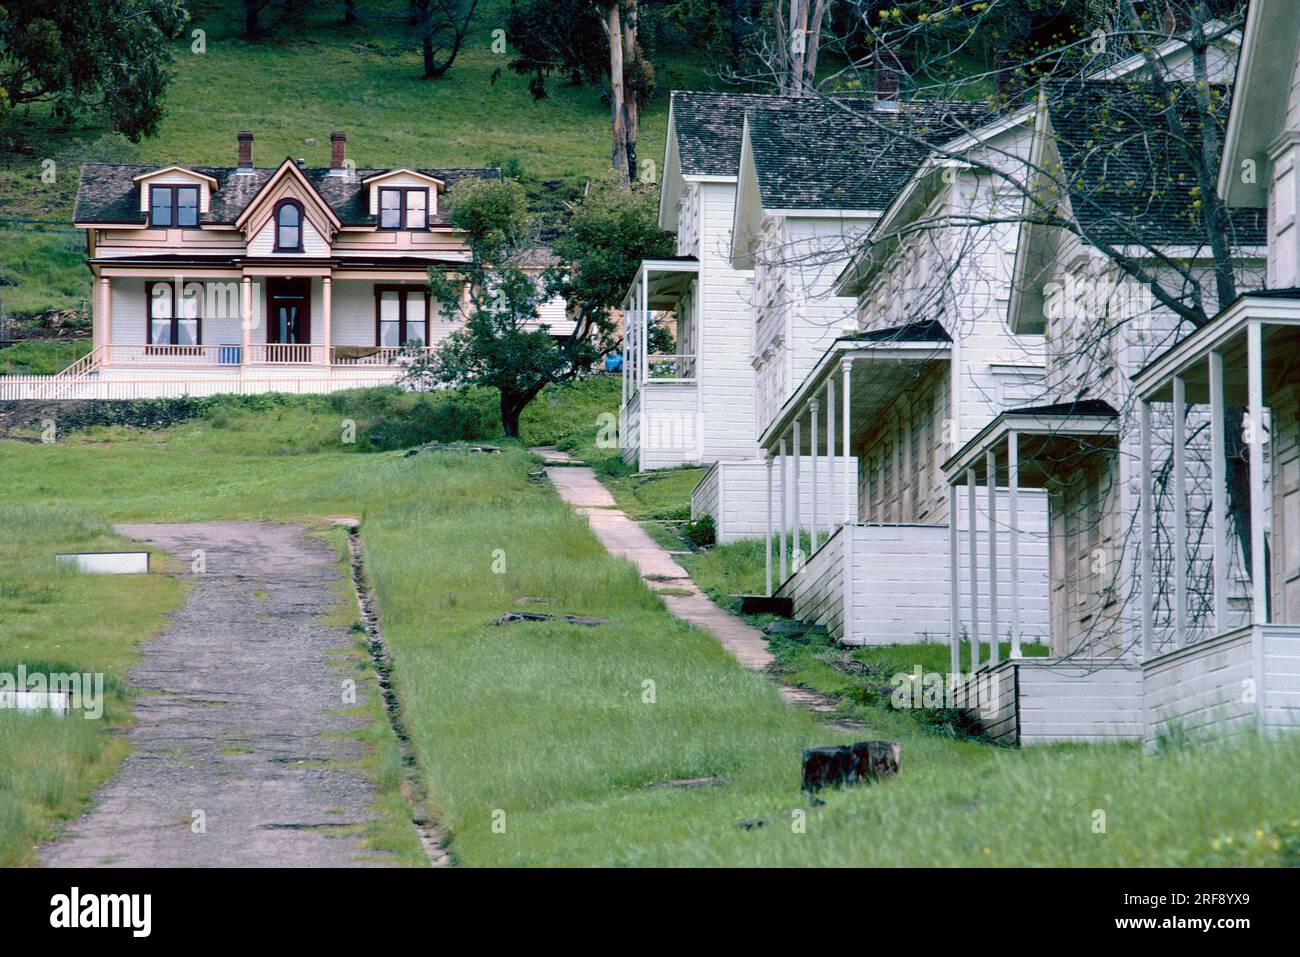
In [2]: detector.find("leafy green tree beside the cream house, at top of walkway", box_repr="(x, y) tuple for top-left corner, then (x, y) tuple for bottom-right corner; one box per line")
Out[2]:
(404, 181), (672, 437)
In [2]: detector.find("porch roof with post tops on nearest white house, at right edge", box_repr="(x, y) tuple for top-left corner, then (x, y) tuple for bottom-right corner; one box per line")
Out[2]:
(1134, 289), (1300, 406)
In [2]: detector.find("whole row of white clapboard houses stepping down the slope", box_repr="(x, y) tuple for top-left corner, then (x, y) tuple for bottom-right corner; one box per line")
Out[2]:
(621, 0), (1300, 745)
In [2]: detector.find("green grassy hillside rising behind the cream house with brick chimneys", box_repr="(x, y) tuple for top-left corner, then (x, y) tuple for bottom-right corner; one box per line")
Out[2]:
(0, 0), (710, 313)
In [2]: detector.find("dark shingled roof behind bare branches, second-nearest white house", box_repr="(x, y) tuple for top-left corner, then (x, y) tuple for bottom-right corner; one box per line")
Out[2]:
(1045, 79), (1266, 246)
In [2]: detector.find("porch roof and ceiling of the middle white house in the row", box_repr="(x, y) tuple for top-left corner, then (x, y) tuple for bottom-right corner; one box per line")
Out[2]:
(759, 339), (952, 454)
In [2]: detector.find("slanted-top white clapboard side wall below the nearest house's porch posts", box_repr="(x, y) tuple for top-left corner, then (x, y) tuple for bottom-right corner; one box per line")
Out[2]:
(1143, 627), (1258, 748)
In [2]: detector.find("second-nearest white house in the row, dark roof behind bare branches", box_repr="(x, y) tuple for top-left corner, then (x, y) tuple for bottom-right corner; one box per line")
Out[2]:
(944, 74), (1262, 744)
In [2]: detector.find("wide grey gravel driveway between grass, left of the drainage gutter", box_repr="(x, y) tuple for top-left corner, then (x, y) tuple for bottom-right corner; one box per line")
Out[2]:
(42, 521), (395, 867)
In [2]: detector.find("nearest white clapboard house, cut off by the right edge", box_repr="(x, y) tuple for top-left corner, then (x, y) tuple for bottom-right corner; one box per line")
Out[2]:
(1134, 0), (1300, 746)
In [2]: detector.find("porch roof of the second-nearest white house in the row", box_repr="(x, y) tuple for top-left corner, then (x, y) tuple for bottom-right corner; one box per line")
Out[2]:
(943, 399), (1119, 489)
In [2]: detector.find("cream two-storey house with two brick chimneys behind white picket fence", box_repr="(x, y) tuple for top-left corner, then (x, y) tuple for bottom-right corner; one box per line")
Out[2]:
(0, 133), (499, 398)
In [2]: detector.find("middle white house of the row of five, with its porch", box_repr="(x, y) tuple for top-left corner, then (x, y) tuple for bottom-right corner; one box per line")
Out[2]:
(759, 98), (1048, 644)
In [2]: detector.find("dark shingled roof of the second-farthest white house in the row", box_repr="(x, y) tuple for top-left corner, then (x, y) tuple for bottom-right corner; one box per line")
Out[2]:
(746, 100), (988, 209)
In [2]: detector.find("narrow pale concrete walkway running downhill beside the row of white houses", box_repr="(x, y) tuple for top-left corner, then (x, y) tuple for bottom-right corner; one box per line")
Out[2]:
(543, 462), (836, 713)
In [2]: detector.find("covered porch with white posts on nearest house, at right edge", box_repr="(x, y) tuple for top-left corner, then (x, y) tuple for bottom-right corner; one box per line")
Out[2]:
(1134, 290), (1300, 745)
